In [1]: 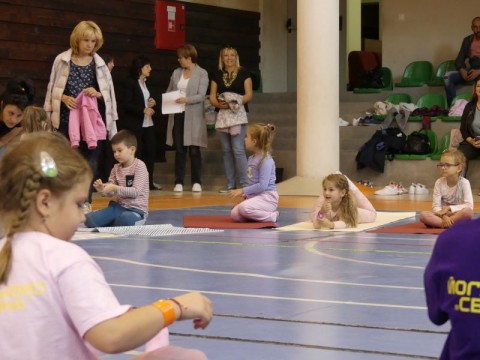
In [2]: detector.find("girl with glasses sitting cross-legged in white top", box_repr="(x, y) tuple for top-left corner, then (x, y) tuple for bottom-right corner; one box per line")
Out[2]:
(420, 150), (473, 228)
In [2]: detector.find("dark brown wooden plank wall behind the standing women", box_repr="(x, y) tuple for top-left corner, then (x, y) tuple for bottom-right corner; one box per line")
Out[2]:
(0, 0), (260, 158)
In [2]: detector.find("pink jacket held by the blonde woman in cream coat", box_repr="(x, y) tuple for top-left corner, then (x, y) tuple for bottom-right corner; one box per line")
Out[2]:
(68, 91), (107, 149)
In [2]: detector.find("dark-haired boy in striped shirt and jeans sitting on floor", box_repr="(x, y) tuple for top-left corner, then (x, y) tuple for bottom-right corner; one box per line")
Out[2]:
(85, 130), (149, 228)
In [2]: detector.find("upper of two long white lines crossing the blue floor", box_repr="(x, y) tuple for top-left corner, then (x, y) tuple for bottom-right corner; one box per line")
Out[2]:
(92, 256), (423, 291)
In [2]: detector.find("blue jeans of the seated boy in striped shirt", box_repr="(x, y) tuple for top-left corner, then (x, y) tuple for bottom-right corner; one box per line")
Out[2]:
(85, 201), (145, 228)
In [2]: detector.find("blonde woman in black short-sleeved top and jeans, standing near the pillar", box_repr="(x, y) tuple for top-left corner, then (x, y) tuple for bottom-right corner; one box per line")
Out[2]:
(210, 46), (253, 193)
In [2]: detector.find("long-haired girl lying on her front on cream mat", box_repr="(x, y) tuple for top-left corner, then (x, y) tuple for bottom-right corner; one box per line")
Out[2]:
(310, 174), (377, 229)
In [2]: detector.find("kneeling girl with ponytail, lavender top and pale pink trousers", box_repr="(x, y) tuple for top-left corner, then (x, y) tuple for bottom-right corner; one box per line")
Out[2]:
(228, 124), (278, 222)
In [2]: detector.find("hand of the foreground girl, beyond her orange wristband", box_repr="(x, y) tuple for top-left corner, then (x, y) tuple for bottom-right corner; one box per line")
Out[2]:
(175, 292), (213, 329)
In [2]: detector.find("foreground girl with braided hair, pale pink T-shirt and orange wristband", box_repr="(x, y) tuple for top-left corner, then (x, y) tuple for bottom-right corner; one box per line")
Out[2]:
(0, 131), (212, 360)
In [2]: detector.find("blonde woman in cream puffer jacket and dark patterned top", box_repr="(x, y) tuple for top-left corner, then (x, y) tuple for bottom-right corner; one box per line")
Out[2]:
(44, 21), (118, 210)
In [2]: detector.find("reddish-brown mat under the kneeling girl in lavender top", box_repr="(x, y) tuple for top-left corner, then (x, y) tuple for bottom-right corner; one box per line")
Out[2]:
(183, 215), (277, 229)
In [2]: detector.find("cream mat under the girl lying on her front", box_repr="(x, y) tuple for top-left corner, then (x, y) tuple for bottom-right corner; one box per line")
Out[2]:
(276, 211), (416, 232)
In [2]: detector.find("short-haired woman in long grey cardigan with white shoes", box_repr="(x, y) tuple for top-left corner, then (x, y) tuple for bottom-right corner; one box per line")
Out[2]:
(167, 44), (208, 192)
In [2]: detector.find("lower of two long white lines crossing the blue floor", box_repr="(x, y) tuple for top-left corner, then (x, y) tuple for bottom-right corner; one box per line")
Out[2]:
(109, 283), (427, 311)
